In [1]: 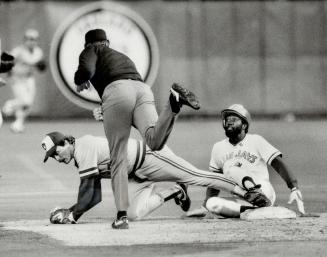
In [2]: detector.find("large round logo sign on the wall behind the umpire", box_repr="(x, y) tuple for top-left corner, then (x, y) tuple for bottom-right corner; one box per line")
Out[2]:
(50, 2), (159, 109)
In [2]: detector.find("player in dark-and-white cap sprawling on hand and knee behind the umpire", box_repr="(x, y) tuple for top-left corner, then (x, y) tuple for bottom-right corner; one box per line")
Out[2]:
(42, 132), (267, 224)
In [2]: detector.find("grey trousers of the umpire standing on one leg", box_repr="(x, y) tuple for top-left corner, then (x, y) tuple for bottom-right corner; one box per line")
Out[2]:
(102, 80), (176, 211)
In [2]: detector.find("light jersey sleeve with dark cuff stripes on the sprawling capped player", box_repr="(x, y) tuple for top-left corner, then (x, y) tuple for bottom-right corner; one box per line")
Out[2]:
(75, 137), (99, 178)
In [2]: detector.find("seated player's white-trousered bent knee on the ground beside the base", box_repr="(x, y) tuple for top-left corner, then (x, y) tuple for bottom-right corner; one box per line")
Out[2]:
(206, 197), (240, 218)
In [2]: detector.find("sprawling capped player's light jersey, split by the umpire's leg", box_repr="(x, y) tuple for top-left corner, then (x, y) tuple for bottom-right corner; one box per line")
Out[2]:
(74, 135), (145, 178)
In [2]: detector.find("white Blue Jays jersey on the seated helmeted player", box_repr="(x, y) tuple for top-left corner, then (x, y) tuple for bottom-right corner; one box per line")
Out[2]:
(209, 134), (281, 181)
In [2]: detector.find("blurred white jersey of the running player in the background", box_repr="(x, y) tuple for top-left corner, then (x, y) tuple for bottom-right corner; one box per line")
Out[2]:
(11, 45), (43, 79)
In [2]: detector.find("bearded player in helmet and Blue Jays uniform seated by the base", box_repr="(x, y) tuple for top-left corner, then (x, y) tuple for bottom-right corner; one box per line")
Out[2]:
(188, 104), (304, 217)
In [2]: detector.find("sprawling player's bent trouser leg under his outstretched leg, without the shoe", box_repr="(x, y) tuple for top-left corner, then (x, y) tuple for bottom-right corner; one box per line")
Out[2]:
(128, 182), (182, 220)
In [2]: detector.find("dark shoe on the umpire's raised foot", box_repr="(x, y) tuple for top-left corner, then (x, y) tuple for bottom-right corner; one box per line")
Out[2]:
(170, 83), (200, 110)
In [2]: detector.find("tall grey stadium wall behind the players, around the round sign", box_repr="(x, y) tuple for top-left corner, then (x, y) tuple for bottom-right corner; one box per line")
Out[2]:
(0, 1), (327, 118)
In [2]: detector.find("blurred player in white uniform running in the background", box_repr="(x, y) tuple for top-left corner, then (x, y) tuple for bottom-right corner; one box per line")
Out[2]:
(2, 29), (46, 133)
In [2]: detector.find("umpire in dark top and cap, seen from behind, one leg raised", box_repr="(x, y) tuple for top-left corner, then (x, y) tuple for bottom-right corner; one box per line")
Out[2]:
(74, 29), (200, 229)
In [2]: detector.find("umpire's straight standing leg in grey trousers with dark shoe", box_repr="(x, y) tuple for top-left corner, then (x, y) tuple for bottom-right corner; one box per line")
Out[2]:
(102, 81), (136, 228)
